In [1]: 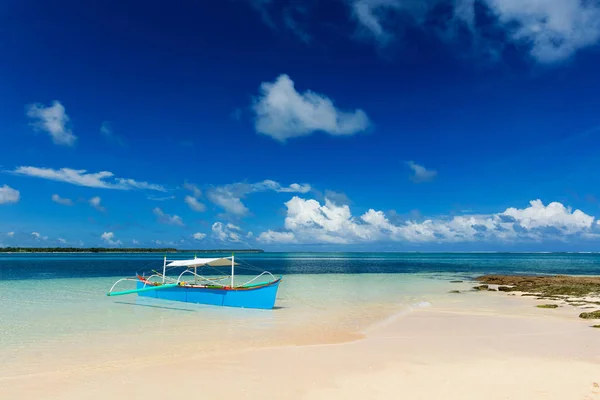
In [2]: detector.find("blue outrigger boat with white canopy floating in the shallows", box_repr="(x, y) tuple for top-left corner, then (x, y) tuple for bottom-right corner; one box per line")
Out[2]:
(106, 254), (282, 309)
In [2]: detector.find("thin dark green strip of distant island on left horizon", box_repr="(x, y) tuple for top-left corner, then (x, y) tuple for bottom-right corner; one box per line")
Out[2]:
(0, 247), (264, 253)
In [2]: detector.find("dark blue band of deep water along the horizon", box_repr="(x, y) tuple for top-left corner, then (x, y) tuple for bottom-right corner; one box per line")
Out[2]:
(0, 253), (600, 280)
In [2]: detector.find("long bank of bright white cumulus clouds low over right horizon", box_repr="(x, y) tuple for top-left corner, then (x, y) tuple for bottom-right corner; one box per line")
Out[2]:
(259, 196), (600, 244)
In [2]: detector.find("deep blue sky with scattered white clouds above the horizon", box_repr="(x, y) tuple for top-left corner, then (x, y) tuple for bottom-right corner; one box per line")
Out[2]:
(0, 0), (600, 251)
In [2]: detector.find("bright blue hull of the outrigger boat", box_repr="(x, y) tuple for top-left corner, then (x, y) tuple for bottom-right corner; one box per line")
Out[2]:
(137, 281), (280, 309)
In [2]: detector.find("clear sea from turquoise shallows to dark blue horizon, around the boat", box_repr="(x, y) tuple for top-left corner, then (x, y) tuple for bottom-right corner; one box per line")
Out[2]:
(0, 253), (600, 378)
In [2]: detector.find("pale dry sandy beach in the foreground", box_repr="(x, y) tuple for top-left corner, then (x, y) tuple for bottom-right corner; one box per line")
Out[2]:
(0, 284), (600, 400)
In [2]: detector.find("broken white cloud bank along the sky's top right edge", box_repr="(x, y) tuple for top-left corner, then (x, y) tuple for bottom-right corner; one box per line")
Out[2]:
(350, 0), (600, 63)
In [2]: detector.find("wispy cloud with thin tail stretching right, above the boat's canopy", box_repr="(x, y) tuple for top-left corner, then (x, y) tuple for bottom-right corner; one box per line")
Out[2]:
(207, 179), (311, 216)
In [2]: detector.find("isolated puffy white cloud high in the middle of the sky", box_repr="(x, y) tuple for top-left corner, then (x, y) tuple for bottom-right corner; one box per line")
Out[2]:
(253, 75), (370, 142)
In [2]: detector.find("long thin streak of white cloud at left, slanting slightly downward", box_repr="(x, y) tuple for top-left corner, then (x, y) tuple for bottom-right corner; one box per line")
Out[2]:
(13, 167), (167, 192)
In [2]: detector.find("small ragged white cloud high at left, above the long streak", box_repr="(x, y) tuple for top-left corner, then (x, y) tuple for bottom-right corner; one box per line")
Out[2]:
(27, 100), (77, 146)
